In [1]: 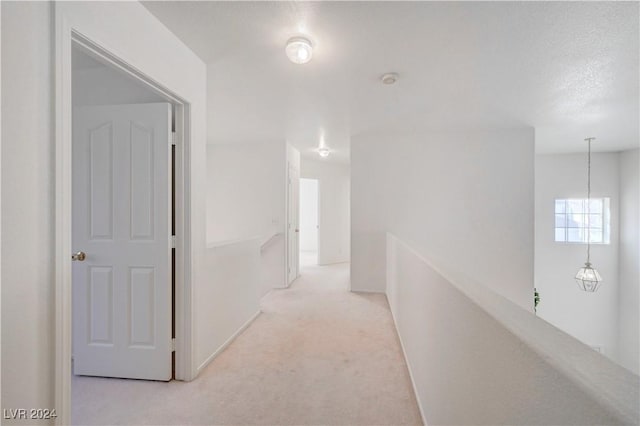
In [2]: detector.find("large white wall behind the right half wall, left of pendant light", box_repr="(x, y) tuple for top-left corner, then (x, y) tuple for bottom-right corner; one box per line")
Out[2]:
(351, 129), (534, 309)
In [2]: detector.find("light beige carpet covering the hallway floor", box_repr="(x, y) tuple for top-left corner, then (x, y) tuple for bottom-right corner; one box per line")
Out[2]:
(72, 264), (421, 425)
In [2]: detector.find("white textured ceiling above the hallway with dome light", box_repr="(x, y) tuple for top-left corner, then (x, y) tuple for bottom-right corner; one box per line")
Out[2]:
(144, 2), (639, 161)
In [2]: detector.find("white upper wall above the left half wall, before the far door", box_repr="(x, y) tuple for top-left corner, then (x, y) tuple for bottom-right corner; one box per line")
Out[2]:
(206, 143), (286, 242)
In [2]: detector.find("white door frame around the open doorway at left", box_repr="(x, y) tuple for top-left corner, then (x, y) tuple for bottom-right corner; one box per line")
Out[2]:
(54, 27), (196, 425)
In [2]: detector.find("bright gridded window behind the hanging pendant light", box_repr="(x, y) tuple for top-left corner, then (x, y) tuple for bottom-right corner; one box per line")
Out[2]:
(555, 198), (610, 244)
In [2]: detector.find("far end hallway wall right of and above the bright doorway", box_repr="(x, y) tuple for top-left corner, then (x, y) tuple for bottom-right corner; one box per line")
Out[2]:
(300, 157), (351, 265)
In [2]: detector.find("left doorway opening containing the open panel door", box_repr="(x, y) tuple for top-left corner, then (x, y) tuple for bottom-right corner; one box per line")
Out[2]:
(63, 38), (189, 421)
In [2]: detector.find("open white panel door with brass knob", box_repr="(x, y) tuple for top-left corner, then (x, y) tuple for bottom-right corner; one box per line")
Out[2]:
(72, 103), (172, 380)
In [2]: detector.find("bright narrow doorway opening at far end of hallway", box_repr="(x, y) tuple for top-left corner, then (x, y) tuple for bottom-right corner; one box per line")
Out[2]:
(300, 178), (320, 269)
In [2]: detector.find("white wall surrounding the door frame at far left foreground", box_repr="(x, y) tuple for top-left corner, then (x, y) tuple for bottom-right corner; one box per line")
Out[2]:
(0, 2), (207, 424)
